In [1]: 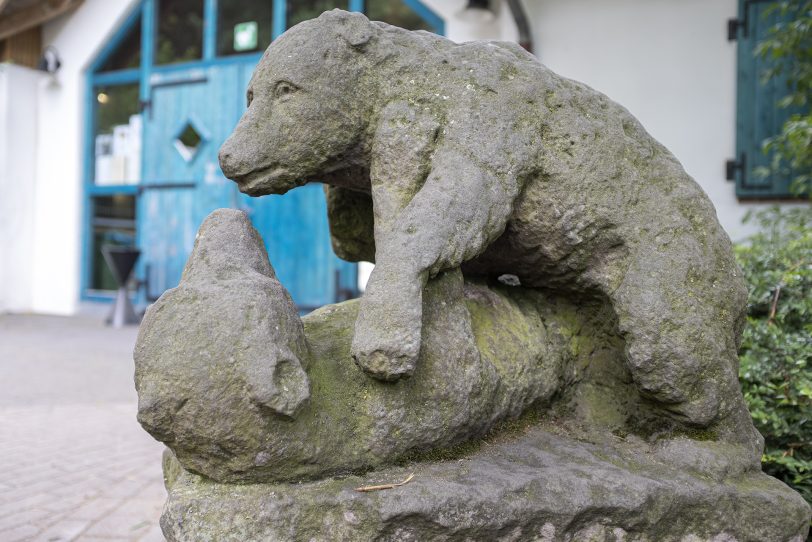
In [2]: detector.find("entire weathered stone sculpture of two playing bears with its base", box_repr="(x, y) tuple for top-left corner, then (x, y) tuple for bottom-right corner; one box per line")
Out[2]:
(135, 10), (809, 541)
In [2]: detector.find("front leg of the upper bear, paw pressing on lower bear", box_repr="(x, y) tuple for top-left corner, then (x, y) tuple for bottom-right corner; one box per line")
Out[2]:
(352, 142), (518, 381)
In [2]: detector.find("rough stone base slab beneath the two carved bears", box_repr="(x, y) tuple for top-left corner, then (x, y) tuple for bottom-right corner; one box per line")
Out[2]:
(161, 427), (810, 542)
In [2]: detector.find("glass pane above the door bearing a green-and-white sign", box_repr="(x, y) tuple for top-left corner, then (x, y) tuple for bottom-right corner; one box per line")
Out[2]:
(217, 0), (273, 56)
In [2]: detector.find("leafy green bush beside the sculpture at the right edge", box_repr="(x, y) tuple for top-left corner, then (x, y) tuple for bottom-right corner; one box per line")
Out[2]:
(736, 206), (812, 503)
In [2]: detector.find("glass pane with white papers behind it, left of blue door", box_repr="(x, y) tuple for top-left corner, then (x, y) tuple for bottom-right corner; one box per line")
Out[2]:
(93, 83), (141, 185)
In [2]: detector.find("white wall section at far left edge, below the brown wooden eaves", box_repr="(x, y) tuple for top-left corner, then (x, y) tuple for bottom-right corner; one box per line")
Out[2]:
(0, 64), (43, 313)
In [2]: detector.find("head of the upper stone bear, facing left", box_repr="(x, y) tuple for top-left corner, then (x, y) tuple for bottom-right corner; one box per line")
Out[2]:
(220, 10), (378, 196)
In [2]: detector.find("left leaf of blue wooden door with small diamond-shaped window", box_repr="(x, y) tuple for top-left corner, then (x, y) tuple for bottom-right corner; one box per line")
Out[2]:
(138, 66), (238, 298)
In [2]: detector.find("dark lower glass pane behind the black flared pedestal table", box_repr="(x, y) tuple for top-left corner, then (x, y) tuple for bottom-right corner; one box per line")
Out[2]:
(90, 194), (135, 290)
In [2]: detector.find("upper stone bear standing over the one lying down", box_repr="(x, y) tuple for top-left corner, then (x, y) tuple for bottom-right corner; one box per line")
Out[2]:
(220, 10), (761, 453)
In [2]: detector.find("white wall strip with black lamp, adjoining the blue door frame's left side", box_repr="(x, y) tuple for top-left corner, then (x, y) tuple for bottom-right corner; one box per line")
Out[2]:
(31, 0), (135, 314)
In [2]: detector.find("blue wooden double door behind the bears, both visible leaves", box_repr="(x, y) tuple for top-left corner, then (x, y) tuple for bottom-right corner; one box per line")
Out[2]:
(138, 63), (356, 310)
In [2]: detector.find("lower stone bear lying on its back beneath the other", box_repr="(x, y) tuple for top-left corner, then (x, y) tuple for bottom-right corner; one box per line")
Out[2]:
(135, 209), (613, 482)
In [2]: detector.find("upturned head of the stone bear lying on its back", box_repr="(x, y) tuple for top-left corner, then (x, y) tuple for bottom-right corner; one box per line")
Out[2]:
(133, 209), (310, 440)
